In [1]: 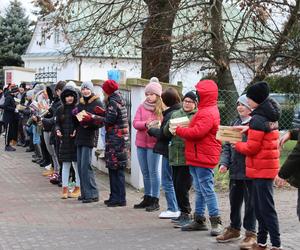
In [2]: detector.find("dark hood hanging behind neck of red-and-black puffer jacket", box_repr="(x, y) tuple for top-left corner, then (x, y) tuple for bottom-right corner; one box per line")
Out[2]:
(251, 97), (281, 122)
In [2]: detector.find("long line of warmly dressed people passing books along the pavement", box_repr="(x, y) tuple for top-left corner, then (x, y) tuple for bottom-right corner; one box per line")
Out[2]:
(0, 77), (300, 250)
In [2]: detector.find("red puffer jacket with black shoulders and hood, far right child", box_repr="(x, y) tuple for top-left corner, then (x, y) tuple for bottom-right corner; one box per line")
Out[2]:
(235, 98), (281, 179)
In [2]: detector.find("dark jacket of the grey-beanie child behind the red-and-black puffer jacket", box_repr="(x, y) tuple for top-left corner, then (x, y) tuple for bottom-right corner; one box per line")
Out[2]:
(220, 118), (248, 180)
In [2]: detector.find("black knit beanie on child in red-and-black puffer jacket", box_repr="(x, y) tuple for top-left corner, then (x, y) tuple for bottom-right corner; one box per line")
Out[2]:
(246, 82), (270, 104)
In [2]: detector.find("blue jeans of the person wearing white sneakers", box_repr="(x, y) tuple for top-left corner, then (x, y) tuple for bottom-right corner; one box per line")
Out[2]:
(161, 156), (178, 212)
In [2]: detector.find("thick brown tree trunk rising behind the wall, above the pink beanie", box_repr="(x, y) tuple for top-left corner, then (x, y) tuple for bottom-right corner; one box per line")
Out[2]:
(142, 0), (180, 82)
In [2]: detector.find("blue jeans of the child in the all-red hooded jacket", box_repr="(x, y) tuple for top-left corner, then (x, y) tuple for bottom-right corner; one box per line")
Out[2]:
(190, 166), (219, 217)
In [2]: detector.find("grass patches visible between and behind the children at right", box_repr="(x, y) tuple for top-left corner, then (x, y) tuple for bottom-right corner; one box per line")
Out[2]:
(215, 141), (297, 191)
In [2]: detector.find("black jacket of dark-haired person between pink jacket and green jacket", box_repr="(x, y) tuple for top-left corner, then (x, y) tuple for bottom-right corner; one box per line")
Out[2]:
(148, 103), (181, 158)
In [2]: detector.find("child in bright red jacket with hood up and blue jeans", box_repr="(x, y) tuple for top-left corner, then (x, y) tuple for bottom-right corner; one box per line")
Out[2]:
(174, 80), (223, 236)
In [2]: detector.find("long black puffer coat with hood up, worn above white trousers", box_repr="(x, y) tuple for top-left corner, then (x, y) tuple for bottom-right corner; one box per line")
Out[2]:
(55, 86), (78, 162)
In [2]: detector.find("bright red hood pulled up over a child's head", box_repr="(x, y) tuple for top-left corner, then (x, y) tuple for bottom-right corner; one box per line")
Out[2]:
(195, 80), (218, 109)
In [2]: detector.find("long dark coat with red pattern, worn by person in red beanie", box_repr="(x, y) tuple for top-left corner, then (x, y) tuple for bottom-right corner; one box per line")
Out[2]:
(104, 91), (129, 169)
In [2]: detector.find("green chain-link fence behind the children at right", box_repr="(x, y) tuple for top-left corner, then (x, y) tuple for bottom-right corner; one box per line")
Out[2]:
(218, 90), (300, 130)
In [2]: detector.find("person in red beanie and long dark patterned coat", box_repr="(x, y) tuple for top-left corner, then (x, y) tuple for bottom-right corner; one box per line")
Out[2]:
(88, 80), (129, 207)
